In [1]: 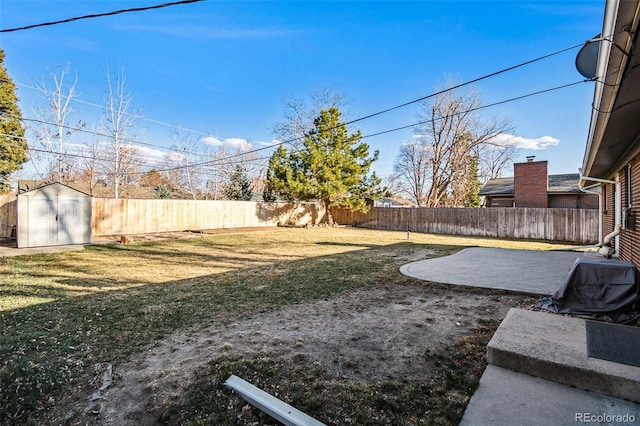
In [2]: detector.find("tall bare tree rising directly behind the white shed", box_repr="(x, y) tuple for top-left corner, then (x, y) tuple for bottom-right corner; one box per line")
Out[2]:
(32, 64), (84, 183)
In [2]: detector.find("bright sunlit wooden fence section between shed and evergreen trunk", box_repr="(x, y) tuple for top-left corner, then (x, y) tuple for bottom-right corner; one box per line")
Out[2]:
(91, 198), (324, 236)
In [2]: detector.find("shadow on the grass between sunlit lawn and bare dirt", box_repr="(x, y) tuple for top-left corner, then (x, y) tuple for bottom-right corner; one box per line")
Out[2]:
(0, 243), (422, 424)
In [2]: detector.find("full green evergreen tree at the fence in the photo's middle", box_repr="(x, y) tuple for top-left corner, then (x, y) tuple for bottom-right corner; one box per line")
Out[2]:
(266, 108), (384, 225)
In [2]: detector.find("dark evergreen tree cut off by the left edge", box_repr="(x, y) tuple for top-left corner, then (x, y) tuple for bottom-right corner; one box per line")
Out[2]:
(0, 49), (29, 193)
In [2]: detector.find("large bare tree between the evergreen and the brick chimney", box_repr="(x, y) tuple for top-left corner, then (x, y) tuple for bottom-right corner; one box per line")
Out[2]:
(394, 83), (510, 207)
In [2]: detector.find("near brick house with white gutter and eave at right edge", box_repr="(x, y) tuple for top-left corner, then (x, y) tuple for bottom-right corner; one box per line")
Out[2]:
(580, 0), (640, 266)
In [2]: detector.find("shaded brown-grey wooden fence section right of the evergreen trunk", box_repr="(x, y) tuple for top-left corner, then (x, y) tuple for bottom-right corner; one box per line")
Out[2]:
(333, 207), (598, 244)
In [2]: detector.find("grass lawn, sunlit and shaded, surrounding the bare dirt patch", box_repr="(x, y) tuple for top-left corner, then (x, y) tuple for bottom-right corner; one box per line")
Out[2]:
(0, 228), (555, 424)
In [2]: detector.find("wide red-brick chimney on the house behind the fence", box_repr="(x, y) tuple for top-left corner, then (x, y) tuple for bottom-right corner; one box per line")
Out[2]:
(513, 157), (549, 208)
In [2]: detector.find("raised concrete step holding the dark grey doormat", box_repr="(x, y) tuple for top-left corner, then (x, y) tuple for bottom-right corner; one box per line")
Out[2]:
(487, 308), (640, 402)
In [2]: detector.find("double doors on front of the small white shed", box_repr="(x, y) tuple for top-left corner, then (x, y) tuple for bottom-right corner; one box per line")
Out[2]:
(29, 196), (84, 247)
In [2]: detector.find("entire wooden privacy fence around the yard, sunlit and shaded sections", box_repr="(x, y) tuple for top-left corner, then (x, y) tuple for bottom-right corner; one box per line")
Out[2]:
(0, 195), (598, 244)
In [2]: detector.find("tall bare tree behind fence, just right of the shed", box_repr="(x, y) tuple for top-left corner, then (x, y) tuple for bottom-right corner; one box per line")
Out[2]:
(101, 67), (142, 198)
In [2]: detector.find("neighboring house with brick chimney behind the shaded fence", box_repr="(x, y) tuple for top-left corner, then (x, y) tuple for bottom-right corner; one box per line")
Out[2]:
(479, 157), (598, 209)
